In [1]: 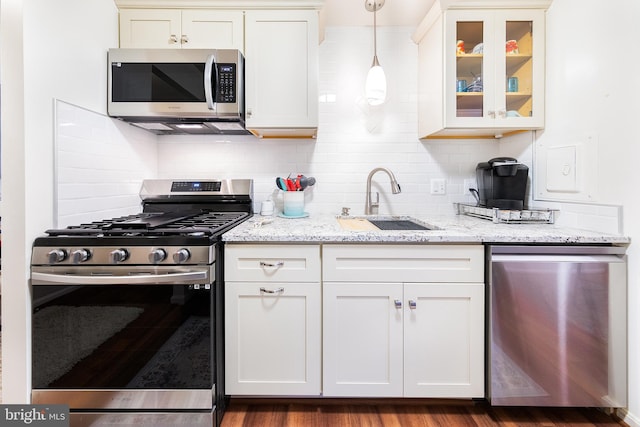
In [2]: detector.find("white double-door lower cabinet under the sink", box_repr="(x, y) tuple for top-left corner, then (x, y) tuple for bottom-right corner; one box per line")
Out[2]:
(323, 245), (484, 398)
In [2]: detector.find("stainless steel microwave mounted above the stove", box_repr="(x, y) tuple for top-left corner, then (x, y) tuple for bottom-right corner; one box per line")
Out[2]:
(107, 49), (249, 134)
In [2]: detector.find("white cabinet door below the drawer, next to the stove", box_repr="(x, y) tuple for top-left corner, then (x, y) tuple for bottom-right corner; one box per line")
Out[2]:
(225, 282), (321, 396)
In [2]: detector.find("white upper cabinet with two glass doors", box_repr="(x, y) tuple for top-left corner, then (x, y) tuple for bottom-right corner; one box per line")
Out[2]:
(414, 2), (545, 138)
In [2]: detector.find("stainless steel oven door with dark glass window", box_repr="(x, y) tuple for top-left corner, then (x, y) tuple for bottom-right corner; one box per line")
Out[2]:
(31, 265), (215, 411)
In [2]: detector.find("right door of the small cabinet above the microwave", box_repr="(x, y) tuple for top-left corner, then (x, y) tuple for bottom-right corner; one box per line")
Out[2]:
(180, 9), (244, 51)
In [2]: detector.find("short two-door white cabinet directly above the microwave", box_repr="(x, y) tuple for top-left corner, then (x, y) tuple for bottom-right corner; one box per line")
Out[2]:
(120, 9), (244, 51)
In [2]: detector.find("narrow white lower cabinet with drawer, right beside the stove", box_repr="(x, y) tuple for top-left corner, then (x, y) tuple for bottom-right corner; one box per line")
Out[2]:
(225, 244), (322, 396)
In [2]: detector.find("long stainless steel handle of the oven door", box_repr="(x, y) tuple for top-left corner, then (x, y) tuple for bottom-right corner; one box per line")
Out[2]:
(31, 271), (209, 285)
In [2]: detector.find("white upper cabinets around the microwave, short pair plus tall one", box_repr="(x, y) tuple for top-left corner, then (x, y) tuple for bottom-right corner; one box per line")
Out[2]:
(116, 0), (322, 138)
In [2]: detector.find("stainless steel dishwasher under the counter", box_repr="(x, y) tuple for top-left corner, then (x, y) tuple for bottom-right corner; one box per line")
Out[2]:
(487, 245), (627, 408)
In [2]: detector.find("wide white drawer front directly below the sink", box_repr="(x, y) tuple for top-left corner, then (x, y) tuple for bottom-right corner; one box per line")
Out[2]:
(322, 244), (484, 283)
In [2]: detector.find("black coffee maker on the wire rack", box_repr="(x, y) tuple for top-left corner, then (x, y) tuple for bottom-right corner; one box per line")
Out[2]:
(476, 157), (529, 210)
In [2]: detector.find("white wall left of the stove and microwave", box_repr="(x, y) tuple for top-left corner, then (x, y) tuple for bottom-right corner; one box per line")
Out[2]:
(0, 0), (118, 403)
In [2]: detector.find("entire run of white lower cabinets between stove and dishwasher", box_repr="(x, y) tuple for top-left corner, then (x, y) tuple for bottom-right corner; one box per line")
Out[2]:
(225, 243), (484, 398)
